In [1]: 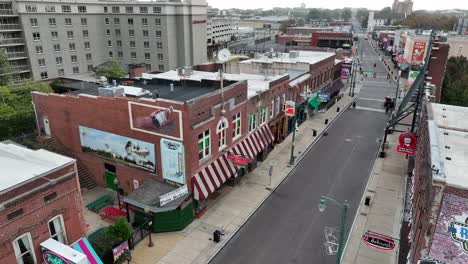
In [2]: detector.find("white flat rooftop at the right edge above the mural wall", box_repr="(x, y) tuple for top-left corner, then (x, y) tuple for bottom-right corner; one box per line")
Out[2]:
(428, 103), (468, 190)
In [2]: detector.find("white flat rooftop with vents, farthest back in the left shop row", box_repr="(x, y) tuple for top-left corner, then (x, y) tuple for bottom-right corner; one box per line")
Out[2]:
(240, 50), (335, 64)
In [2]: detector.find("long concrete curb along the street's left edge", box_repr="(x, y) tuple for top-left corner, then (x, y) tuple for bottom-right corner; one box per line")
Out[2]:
(205, 97), (356, 264)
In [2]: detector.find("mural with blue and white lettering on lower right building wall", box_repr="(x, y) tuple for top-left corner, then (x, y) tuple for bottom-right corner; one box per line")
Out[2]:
(429, 193), (468, 264)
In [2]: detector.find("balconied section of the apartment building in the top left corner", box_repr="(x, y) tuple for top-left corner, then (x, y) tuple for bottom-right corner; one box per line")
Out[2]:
(0, 1), (31, 80)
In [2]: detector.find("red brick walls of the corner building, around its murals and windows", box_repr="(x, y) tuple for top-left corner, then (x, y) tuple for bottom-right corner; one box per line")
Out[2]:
(33, 82), (247, 192)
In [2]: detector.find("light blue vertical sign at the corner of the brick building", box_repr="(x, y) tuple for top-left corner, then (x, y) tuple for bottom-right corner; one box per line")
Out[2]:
(161, 138), (185, 184)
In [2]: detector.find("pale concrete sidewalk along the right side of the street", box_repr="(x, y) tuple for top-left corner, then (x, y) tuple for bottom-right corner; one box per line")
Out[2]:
(342, 128), (408, 264)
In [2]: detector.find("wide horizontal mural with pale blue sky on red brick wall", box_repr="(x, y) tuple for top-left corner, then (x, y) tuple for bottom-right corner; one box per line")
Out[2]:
(79, 126), (156, 172)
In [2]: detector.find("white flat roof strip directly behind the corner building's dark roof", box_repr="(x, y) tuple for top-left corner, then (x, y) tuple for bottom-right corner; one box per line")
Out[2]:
(143, 71), (288, 98)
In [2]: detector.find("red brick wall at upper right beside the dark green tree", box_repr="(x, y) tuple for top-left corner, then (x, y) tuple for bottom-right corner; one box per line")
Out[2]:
(427, 42), (450, 103)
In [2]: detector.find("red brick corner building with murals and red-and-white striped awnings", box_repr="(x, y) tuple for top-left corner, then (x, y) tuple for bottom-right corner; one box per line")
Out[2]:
(33, 70), (287, 218)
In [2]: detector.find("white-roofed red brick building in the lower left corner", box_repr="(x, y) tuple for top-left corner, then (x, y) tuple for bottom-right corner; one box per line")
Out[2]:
(0, 143), (86, 264)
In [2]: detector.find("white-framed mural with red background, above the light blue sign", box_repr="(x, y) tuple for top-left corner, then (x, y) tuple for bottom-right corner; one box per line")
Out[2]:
(128, 102), (183, 140)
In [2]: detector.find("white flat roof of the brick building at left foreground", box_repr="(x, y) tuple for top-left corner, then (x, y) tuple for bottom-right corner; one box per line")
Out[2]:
(0, 142), (74, 192)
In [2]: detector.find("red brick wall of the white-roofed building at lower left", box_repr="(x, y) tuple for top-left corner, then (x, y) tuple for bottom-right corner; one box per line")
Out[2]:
(0, 164), (86, 263)
